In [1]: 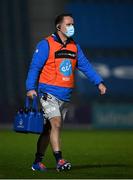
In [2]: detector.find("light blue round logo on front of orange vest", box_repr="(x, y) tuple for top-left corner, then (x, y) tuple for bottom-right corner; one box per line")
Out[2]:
(60, 59), (72, 76)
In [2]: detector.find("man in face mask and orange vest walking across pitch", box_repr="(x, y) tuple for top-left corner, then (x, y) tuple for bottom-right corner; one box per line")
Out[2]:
(26, 14), (106, 171)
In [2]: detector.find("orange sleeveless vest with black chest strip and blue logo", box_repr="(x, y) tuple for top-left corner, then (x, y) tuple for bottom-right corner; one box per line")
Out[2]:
(39, 36), (77, 88)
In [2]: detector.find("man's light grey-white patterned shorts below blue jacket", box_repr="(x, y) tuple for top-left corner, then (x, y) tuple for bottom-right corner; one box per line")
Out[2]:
(40, 93), (69, 120)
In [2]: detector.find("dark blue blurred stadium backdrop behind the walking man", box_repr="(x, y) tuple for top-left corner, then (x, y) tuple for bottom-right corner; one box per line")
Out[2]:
(0, 0), (133, 127)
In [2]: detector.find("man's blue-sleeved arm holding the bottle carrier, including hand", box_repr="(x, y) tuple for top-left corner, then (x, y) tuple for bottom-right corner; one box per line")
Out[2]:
(26, 40), (49, 97)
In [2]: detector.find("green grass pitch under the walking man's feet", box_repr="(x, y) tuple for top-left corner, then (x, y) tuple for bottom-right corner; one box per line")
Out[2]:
(0, 130), (133, 179)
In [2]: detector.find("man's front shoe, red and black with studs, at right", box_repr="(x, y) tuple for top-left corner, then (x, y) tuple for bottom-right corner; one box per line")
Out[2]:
(56, 159), (71, 171)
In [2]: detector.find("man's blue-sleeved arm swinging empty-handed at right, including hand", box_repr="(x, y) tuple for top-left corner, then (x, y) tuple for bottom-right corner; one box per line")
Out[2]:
(77, 45), (106, 95)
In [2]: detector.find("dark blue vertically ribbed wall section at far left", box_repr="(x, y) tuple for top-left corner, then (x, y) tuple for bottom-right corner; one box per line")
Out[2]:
(0, 0), (30, 105)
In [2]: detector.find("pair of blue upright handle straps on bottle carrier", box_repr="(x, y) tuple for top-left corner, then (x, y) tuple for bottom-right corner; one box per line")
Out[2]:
(25, 95), (38, 111)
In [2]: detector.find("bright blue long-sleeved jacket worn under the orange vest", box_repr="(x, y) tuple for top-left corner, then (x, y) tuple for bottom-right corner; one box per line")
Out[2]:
(26, 34), (103, 101)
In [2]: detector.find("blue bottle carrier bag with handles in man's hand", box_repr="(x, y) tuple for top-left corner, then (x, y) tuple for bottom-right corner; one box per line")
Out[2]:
(13, 96), (45, 134)
